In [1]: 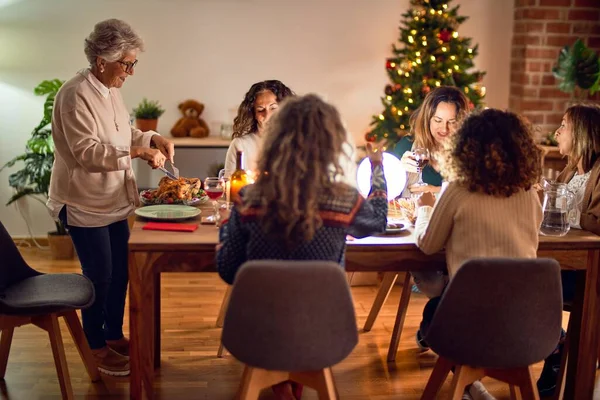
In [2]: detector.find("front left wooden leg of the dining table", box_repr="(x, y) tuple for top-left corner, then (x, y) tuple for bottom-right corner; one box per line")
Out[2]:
(129, 252), (160, 399)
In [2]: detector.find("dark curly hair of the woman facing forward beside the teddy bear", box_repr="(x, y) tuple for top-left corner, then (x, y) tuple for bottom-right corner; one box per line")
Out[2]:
(232, 79), (294, 138)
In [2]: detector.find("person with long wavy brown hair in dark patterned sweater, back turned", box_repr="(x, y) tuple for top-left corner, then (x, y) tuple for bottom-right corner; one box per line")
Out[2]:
(217, 95), (387, 399)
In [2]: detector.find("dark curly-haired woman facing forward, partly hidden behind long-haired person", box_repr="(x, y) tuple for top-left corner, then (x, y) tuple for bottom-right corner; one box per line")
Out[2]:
(225, 80), (294, 177)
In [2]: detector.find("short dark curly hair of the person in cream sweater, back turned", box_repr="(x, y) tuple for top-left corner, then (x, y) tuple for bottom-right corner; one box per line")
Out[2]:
(442, 109), (542, 197)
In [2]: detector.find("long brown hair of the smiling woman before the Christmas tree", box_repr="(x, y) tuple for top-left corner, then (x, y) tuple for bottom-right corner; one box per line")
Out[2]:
(409, 86), (469, 151)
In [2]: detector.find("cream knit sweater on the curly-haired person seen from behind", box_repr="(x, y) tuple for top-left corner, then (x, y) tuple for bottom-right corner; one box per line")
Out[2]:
(415, 182), (542, 277)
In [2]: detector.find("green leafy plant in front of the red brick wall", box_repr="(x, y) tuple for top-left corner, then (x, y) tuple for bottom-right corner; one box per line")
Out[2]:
(552, 39), (600, 101)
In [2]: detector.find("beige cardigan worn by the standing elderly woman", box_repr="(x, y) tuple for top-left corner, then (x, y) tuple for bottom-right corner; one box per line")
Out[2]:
(48, 70), (156, 227)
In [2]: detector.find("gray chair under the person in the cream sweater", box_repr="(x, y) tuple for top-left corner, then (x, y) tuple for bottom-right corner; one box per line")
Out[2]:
(422, 258), (562, 399)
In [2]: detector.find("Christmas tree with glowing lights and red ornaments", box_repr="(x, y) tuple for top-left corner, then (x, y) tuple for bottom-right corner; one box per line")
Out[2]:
(365, 0), (485, 147)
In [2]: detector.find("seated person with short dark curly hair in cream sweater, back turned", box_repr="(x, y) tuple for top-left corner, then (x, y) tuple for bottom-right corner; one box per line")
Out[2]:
(415, 109), (542, 398)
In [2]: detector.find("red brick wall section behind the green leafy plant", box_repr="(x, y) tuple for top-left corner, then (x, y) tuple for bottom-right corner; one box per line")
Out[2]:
(509, 0), (600, 139)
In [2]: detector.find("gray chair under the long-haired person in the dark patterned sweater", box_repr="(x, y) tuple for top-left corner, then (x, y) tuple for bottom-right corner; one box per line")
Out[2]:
(222, 261), (358, 400)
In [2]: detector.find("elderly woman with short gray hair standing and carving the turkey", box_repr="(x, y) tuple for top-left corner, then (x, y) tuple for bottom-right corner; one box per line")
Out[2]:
(48, 19), (174, 376)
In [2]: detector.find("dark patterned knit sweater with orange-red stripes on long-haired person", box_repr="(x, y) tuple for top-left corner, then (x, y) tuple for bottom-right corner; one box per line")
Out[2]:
(217, 164), (388, 284)
